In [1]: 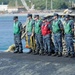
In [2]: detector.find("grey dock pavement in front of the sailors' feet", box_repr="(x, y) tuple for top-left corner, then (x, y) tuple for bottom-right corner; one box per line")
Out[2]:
(0, 52), (75, 75)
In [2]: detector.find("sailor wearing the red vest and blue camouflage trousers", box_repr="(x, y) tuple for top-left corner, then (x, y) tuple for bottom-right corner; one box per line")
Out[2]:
(41, 17), (51, 56)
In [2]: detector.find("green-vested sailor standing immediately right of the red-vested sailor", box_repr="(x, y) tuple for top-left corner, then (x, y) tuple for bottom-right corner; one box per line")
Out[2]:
(52, 13), (63, 57)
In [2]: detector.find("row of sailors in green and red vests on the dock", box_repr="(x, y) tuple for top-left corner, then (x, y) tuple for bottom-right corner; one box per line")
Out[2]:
(14, 13), (75, 58)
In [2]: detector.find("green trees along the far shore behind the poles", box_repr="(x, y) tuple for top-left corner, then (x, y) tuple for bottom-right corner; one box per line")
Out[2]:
(0, 0), (75, 10)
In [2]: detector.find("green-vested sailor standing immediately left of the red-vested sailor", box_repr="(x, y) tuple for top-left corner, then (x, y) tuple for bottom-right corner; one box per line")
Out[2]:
(34, 15), (43, 55)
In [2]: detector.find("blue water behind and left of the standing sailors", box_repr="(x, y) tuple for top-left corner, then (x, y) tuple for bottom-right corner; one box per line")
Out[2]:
(0, 16), (27, 51)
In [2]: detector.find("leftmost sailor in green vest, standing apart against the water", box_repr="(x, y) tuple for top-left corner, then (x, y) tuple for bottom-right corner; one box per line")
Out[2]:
(13, 16), (23, 53)
